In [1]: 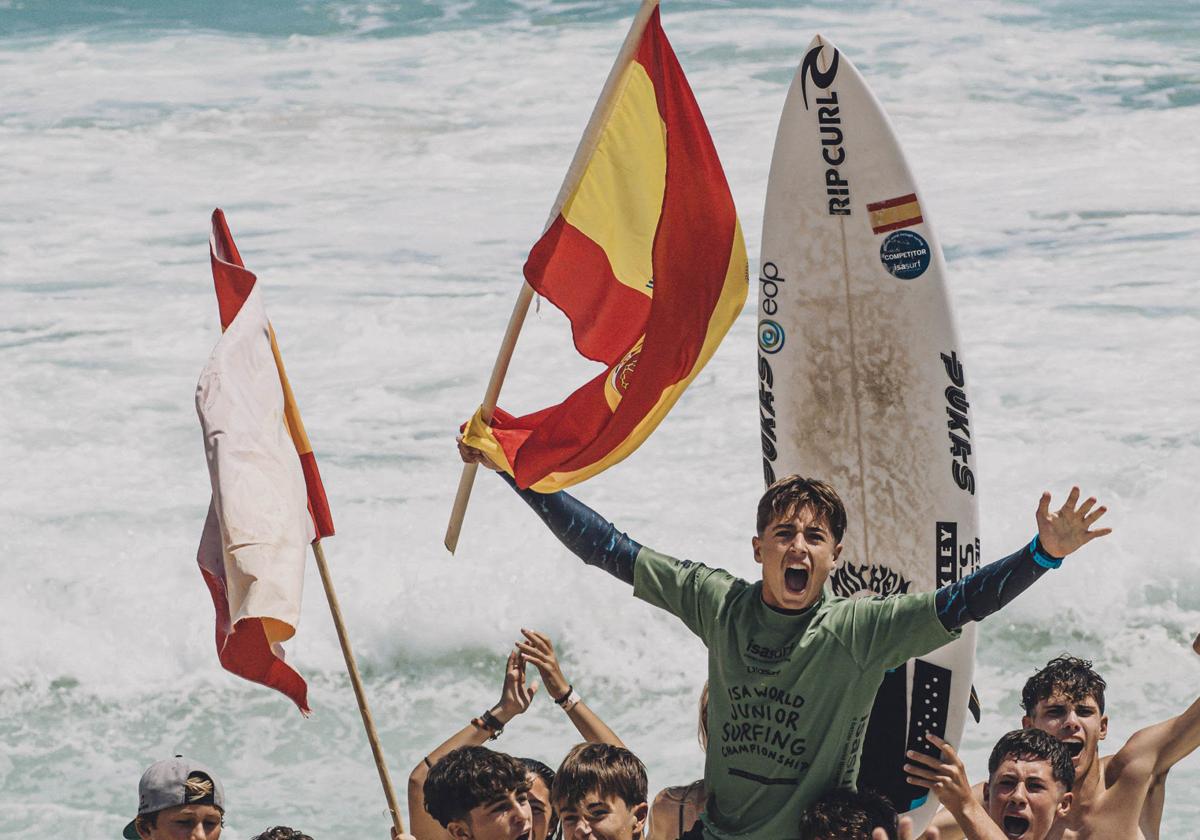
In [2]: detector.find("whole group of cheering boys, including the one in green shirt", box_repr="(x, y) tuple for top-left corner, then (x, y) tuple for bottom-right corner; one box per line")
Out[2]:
(125, 440), (1200, 840)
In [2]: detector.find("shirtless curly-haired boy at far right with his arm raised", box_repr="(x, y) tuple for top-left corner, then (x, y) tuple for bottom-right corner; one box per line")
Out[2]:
(932, 656), (1200, 840)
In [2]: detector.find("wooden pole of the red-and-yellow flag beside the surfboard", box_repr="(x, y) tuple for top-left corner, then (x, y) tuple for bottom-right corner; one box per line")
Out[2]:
(445, 0), (659, 554)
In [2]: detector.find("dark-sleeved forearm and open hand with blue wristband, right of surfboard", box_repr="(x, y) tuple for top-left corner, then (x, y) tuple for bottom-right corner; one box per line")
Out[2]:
(937, 487), (1112, 630)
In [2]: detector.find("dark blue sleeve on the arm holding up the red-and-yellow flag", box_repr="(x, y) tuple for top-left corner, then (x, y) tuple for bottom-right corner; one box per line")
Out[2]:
(499, 473), (642, 586)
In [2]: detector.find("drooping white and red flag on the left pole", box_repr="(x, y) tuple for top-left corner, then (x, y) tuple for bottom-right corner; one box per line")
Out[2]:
(196, 210), (334, 714)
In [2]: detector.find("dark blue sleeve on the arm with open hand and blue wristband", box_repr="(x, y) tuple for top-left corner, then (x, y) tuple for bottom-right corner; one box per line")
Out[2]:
(936, 536), (1062, 630)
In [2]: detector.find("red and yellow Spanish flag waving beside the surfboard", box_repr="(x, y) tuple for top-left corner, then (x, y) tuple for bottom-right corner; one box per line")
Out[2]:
(464, 10), (748, 492)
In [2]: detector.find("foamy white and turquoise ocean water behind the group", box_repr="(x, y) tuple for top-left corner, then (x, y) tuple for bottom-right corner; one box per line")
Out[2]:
(0, 0), (1200, 838)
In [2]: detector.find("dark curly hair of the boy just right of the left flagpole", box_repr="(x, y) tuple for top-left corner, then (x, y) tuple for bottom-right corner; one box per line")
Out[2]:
(425, 746), (529, 828)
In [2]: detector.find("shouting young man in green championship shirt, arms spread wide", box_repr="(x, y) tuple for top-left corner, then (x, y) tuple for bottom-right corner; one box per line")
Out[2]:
(458, 439), (1109, 840)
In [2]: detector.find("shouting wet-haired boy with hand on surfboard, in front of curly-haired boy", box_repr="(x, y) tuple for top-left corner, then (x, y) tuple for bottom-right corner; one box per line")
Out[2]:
(905, 728), (1075, 840)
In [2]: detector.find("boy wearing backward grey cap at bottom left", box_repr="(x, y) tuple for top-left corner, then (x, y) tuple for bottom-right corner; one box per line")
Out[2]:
(122, 756), (224, 840)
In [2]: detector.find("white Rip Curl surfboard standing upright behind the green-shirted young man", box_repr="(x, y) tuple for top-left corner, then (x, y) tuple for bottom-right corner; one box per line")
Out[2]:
(758, 35), (979, 827)
